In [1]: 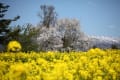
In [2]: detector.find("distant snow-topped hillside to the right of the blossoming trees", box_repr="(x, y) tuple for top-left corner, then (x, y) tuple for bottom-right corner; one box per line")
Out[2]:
(89, 36), (120, 49)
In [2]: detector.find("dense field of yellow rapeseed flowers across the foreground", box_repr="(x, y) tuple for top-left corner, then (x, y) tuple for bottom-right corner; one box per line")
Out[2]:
(0, 48), (120, 80)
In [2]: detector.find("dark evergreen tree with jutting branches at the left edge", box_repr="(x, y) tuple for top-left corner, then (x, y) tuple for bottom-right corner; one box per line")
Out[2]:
(0, 3), (20, 51)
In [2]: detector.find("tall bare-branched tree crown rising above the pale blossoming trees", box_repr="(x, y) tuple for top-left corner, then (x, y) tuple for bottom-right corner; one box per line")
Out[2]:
(39, 5), (57, 28)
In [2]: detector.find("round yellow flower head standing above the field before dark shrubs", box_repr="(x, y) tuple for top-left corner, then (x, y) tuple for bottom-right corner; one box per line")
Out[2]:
(7, 41), (22, 52)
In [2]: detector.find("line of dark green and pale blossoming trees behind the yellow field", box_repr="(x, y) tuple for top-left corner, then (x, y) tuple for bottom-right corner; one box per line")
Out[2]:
(0, 3), (116, 52)
